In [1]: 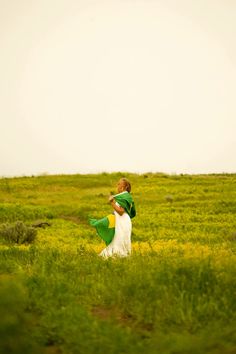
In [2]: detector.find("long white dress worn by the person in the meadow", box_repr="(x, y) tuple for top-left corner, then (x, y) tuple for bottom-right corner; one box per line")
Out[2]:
(99, 203), (132, 258)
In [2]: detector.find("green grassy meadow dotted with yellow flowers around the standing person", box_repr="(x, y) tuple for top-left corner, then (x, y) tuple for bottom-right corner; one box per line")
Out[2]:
(0, 172), (236, 354)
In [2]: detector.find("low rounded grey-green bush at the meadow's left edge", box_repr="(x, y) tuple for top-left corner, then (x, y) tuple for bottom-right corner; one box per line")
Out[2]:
(0, 221), (37, 244)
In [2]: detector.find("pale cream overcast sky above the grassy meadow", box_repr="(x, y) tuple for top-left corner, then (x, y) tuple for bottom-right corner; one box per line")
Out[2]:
(0, 0), (236, 176)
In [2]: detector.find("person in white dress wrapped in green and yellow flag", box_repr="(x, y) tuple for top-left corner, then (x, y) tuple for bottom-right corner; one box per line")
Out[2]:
(90, 178), (136, 258)
